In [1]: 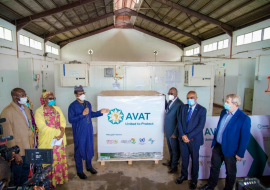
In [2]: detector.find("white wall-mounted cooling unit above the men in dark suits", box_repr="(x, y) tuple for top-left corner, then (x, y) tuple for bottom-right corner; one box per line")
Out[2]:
(184, 65), (212, 86)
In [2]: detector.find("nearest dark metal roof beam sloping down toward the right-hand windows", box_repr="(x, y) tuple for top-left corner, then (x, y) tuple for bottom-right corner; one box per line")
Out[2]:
(156, 0), (234, 36)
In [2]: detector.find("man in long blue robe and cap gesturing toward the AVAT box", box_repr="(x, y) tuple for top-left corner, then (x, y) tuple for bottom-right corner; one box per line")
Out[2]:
(68, 85), (109, 179)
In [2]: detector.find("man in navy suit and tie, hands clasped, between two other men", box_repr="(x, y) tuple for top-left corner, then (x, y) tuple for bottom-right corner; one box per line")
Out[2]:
(175, 91), (206, 189)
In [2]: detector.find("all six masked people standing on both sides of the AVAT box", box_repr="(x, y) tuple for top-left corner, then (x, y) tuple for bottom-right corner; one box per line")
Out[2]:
(1, 86), (251, 190)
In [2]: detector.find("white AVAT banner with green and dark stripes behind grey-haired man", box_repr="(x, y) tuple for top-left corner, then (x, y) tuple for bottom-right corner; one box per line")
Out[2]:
(192, 115), (270, 179)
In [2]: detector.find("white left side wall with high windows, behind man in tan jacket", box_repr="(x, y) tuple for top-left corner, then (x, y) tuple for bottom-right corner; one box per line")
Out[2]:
(0, 18), (60, 112)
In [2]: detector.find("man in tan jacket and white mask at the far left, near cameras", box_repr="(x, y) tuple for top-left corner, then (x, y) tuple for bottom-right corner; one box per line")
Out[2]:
(1, 88), (34, 186)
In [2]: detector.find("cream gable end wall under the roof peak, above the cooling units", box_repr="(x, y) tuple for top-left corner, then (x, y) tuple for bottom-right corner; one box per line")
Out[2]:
(61, 29), (183, 63)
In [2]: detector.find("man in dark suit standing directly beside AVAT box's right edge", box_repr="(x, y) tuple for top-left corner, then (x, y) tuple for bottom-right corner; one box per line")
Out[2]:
(163, 88), (183, 173)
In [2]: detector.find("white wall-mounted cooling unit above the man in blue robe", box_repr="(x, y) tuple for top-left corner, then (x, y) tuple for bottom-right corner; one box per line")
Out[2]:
(60, 64), (90, 86)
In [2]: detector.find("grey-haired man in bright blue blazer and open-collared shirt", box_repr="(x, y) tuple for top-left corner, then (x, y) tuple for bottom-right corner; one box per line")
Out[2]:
(200, 94), (251, 190)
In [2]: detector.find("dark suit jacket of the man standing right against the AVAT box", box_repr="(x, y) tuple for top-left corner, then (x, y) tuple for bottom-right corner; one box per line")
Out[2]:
(164, 97), (184, 137)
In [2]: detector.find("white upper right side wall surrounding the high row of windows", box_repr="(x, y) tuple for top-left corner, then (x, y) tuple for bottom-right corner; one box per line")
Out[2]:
(182, 19), (270, 63)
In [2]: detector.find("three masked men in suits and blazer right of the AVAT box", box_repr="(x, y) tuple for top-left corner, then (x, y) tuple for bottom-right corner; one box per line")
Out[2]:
(163, 88), (251, 190)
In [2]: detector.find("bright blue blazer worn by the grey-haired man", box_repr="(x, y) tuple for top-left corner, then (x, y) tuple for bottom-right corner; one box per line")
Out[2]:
(212, 109), (251, 158)
